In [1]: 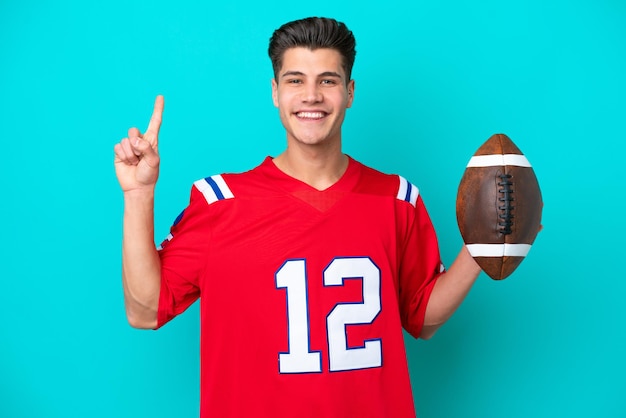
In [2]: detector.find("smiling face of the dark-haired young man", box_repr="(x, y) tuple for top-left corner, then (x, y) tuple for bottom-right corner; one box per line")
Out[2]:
(272, 47), (354, 150)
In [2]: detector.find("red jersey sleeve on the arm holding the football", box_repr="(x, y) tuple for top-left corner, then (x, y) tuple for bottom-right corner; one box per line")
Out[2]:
(399, 196), (445, 338)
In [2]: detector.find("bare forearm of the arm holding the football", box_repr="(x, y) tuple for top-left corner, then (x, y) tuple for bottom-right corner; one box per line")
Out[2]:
(420, 246), (481, 339)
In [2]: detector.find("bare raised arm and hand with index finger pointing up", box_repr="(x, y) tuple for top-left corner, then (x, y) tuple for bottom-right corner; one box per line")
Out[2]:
(114, 96), (164, 329)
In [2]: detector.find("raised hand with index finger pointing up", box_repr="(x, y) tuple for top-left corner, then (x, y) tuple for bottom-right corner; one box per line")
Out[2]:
(114, 96), (164, 192)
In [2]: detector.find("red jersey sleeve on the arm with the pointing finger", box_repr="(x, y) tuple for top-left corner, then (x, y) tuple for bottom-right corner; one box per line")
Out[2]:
(157, 185), (210, 328)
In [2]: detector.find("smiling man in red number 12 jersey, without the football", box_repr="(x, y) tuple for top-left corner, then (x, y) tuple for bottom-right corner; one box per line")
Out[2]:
(115, 18), (480, 418)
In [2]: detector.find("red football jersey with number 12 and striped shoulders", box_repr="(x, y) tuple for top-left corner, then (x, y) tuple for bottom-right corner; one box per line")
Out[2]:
(158, 157), (443, 418)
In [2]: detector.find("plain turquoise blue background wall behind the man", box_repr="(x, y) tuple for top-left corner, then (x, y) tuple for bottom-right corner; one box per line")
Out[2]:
(0, 0), (626, 418)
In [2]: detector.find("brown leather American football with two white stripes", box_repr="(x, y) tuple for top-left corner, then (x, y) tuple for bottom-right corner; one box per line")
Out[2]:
(456, 134), (543, 280)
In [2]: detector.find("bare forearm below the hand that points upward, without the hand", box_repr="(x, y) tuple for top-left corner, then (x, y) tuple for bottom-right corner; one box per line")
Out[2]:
(122, 190), (161, 328)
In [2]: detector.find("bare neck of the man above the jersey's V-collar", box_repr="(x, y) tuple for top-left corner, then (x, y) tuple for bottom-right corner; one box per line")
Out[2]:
(274, 147), (348, 190)
